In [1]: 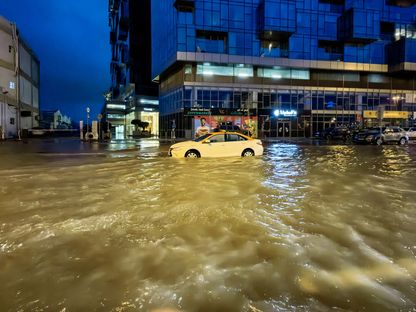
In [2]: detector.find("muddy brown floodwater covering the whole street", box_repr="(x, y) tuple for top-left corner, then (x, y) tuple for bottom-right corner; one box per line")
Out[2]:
(0, 141), (416, 312)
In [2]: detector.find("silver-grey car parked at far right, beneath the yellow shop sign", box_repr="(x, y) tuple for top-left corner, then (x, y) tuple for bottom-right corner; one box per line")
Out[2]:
(353, 127), (409, 145)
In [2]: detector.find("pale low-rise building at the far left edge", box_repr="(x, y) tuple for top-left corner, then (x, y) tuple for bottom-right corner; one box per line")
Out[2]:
(0, 16), (40, 139)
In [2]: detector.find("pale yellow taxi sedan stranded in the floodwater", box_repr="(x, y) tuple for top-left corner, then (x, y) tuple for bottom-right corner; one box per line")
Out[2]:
(168, 132), (263, 158)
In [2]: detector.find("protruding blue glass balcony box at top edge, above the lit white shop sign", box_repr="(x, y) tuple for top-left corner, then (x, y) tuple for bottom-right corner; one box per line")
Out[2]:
(257, 0), (296, 39)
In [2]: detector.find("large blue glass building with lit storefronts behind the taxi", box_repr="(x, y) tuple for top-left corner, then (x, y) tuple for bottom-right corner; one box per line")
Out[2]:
(151, 0), (416, 137)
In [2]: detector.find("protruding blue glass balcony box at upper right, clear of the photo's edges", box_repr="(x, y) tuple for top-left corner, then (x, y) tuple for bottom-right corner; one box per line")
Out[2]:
(338, 8), (380, 44)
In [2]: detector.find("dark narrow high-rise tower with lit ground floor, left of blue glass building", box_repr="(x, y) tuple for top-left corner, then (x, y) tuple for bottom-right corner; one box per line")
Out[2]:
(102, 0), (159, 139)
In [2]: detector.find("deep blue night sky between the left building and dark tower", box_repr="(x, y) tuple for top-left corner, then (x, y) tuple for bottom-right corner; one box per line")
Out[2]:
(0, 0), (111, 122)
